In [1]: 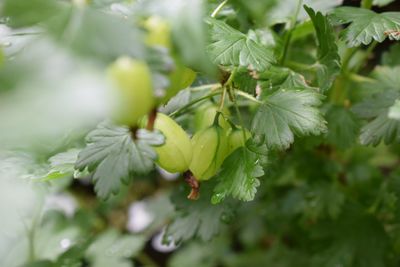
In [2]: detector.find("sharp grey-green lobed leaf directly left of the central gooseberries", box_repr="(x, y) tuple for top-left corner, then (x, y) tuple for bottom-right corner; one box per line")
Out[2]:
(75, 123), (164, 199)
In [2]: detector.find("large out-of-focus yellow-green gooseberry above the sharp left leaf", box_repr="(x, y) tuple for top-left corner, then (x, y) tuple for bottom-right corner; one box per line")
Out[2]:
(108, 57), (155, 127)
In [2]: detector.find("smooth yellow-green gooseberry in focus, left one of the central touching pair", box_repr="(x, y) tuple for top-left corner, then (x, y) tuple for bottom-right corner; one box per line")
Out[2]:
(142, 113), (192, 173)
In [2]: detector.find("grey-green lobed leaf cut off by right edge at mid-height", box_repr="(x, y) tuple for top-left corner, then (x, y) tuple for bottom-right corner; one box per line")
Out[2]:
(353, 67), (400, 146)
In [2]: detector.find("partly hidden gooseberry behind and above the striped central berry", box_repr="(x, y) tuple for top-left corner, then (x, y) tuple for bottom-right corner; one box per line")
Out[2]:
(194, 102), (230, 131)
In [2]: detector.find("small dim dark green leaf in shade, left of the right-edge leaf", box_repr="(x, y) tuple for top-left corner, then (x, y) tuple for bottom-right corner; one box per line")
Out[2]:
(325, 106), (360, 149)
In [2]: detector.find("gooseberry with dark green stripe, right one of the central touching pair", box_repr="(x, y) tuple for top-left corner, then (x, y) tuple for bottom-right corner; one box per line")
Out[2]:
(189, 125), (229, 181)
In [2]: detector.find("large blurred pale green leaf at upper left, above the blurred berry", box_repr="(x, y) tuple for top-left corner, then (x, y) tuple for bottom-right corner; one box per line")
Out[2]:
(46, 7), (145, 62)
